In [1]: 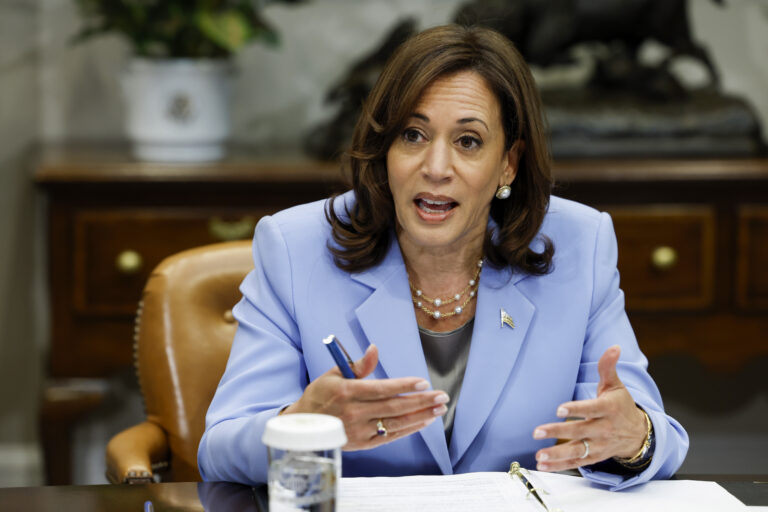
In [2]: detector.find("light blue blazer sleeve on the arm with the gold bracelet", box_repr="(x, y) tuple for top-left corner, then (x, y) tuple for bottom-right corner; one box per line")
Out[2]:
(574, 213), (688, 490)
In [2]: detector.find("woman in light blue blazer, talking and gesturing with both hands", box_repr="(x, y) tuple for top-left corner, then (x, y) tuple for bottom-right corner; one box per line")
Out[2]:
(198, 26), (688, 489)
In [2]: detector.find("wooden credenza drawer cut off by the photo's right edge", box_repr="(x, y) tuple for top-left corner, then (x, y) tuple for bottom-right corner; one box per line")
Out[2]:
(736, 206), (768, 310)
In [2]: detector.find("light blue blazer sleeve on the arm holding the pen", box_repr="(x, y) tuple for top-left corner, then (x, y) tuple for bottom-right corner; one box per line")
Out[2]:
(197, 217), (307, 484)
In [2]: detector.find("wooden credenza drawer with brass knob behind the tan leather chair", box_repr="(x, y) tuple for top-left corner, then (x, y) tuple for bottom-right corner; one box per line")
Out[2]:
(72, 209), (271, 316)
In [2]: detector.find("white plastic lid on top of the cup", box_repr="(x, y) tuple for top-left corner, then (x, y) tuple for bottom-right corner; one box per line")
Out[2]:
(261, 413), (347, 451)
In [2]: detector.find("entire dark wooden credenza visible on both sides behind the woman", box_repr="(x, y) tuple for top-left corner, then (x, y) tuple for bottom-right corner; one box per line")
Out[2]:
(36, 147), (768, 484)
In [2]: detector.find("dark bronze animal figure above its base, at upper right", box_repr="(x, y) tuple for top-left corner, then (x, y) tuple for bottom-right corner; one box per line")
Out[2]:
(454, 0), (723, 93)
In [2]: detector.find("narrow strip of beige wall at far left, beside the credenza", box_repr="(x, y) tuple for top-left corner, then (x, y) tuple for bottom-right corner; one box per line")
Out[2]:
(0, 0), (45, 485)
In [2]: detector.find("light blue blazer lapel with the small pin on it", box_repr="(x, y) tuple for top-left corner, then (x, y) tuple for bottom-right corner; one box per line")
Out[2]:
(450, 265), (536, 465)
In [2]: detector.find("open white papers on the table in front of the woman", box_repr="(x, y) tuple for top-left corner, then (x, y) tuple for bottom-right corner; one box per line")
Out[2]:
(338, 471), (750, 512)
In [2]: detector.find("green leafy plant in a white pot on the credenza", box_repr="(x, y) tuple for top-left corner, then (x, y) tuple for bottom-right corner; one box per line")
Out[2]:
(75, 0), (301, 162)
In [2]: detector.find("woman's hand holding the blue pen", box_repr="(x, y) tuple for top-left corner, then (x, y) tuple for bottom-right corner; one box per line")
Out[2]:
(282, 345), (449, 450)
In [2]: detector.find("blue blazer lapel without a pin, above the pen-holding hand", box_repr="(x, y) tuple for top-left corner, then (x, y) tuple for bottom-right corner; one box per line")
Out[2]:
(352, 237), (453, 474)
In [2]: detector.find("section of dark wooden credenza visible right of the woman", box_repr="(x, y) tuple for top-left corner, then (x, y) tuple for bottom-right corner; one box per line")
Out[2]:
(555, 159), (768, 373)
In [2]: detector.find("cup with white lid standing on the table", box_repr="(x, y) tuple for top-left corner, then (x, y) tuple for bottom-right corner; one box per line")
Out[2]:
(262, 413), (347, 512)
